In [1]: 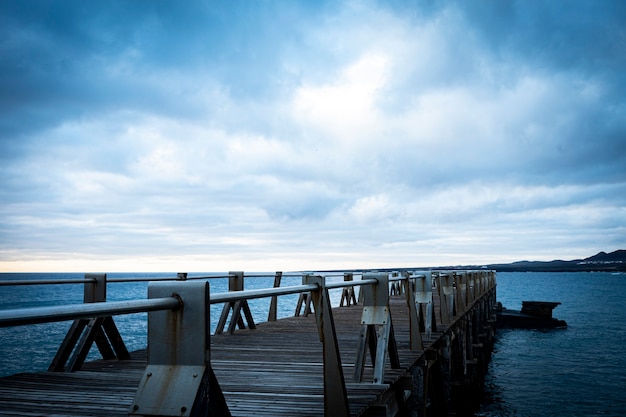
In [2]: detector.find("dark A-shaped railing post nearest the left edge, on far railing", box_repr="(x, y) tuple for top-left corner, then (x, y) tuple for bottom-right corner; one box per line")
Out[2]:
(48, 274), (130, 372)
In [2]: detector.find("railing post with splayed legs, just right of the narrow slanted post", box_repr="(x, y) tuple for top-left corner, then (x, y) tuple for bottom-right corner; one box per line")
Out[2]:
(354, 273), (400, 384)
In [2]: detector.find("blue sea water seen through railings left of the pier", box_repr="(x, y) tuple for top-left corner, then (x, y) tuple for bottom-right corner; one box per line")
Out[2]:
(0, 273), (310, 376)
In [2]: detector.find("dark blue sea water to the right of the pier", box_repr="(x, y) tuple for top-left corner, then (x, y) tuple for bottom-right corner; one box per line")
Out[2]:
(478, 272), (626, 417)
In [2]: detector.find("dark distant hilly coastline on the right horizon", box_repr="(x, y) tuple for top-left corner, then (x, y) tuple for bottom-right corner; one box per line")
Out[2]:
(485, 249), (626, 272)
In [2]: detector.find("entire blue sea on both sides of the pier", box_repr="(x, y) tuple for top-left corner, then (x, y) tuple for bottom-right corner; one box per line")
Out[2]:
(0, 272), (626, 417)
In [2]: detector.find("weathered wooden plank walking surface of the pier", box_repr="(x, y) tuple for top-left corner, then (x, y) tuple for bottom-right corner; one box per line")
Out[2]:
(0, 297), (448, 417)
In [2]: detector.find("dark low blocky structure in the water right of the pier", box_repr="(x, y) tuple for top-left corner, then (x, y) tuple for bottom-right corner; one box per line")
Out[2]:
(496, 301), (567, 329)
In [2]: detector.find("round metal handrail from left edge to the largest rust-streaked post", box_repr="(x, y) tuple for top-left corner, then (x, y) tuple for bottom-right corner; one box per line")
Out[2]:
(0, 297), (182, 327)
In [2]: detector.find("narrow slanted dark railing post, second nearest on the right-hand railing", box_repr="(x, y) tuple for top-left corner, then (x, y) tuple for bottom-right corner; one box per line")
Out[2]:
(302, 275), (350, 417)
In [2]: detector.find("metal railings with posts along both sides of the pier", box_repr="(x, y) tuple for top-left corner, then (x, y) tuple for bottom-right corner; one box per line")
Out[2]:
(0, 271), (495, 416)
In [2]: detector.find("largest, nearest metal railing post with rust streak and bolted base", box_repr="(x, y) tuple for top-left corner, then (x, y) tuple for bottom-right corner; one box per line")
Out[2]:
(129, 281), (230, 417)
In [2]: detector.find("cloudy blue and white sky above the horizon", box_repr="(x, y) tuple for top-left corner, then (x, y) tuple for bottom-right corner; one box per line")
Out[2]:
(0, 0), (626, 272)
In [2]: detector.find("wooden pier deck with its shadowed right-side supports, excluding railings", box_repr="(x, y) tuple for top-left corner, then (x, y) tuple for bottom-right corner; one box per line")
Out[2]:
(0, 270), (495, 417)
